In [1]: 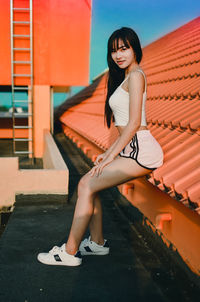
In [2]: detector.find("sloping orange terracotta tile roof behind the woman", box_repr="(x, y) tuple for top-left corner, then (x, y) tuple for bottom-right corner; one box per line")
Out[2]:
(58, 17), (200, 214)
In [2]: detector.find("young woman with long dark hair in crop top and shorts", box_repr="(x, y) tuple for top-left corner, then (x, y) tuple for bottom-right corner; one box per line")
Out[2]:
(38, 27), (163, 266)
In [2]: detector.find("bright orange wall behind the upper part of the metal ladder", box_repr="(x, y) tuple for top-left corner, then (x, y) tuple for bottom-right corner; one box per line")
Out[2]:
(0, 0), (91, 86)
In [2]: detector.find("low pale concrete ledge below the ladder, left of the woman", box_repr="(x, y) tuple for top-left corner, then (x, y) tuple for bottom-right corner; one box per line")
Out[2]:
(0, 130), (69, 208)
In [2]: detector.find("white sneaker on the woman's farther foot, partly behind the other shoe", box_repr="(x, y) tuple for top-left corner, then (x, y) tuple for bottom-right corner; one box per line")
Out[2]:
(79, 236), (110, 256)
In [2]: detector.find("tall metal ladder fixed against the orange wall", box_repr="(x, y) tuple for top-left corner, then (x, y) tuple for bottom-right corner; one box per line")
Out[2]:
(10, 0), (34, 160)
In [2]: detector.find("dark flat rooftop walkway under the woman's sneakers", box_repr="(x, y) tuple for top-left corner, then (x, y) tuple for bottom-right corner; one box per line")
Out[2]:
(0, 135), (200, 302)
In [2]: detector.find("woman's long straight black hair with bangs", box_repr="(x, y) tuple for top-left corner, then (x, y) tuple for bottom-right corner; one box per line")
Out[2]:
(105, 27), (142, 128)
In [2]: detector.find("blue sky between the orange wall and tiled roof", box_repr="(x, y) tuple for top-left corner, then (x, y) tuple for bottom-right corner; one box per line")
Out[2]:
(90, 0), (200, 81)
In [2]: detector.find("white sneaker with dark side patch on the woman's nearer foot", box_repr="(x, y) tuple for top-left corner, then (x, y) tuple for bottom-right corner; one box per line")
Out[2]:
(37, 243), (82, 266)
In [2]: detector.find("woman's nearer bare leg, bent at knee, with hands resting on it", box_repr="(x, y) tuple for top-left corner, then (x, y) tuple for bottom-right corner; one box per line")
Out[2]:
(66, 158), (151, 255)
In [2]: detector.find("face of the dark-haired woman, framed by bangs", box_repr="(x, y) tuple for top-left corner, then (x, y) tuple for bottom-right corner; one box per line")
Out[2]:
(111, 39), (137, 69)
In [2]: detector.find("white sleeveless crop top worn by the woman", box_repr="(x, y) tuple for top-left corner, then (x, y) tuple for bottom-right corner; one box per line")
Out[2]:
(109, 69), (147, 126)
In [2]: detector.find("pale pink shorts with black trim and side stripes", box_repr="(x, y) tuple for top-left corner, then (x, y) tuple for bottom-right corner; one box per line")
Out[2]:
(119, 130), (163, 170)
